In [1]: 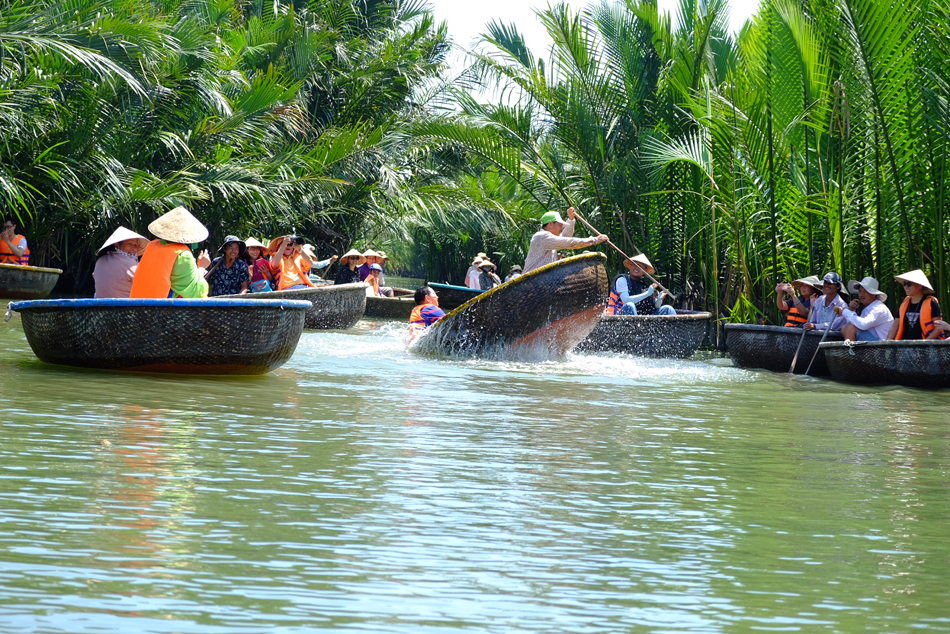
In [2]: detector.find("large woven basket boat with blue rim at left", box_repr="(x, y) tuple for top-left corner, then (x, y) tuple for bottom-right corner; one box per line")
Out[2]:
(9, 299), (310, 374)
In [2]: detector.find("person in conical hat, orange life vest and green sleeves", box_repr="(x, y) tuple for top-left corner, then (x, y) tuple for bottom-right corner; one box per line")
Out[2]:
(129, 207), (211, 299)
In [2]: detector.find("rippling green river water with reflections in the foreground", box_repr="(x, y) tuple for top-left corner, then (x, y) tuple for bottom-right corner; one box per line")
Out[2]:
(0, 302), (950, 634)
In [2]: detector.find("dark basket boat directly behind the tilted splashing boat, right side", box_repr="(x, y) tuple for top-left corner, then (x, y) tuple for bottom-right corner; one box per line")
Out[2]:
(577, 310), (712, 358)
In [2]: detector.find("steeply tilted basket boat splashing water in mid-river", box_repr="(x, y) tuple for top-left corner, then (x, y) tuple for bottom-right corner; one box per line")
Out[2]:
(413, 253), (610, 359)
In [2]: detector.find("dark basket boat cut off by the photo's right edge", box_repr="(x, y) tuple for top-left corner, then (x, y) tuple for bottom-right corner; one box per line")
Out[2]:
(820, 339), (950, 387)
